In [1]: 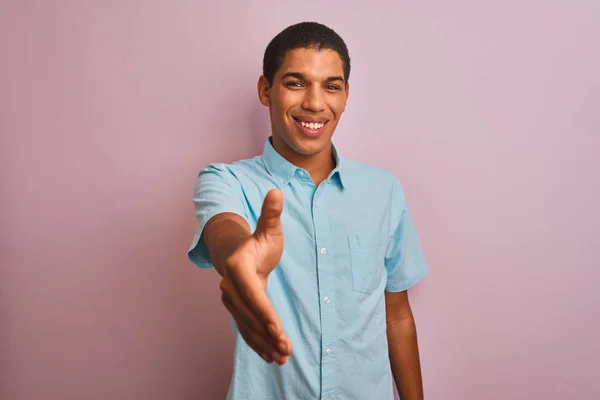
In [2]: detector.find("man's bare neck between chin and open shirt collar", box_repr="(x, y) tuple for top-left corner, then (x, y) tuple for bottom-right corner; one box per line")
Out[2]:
(270, 135), (335, 186)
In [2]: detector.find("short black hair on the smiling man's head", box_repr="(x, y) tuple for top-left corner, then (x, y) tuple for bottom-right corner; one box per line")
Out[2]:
(263, 22), (350, 85)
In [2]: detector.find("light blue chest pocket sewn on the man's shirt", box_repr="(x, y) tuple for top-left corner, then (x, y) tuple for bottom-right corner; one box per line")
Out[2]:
(348, 231), (390, 294)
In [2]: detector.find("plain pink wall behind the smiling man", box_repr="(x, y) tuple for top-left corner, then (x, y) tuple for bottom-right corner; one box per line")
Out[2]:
(0, 0), (600, 400)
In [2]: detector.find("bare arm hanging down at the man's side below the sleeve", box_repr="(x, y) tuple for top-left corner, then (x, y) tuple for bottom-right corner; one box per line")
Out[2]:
(385, 291), (423, 400)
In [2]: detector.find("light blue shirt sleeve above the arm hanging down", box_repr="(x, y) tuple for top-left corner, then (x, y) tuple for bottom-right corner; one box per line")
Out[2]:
(385, 178), (429, 292)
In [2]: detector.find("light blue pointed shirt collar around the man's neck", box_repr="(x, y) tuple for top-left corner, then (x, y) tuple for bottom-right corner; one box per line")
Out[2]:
(262, 137), (348, 189)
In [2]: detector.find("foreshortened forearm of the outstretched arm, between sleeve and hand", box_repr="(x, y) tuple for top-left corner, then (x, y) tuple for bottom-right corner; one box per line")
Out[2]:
(202, 213), (251, 276)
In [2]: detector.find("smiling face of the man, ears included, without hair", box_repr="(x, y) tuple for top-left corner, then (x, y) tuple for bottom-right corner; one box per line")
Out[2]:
(258, 48), (349, 163)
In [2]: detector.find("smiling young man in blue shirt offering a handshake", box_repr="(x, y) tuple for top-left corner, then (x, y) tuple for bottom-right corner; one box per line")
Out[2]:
(189, 23), (427, 400)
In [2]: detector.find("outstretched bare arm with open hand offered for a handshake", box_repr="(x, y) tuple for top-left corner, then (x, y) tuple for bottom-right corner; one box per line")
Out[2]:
(202, 191), (292, 364)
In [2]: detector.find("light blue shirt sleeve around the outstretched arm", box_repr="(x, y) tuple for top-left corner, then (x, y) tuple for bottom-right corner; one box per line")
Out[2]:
(188, 164), (247, 269)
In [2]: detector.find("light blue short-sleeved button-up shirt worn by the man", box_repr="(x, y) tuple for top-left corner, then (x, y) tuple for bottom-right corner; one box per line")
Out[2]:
(188, 139), (427, 400)
